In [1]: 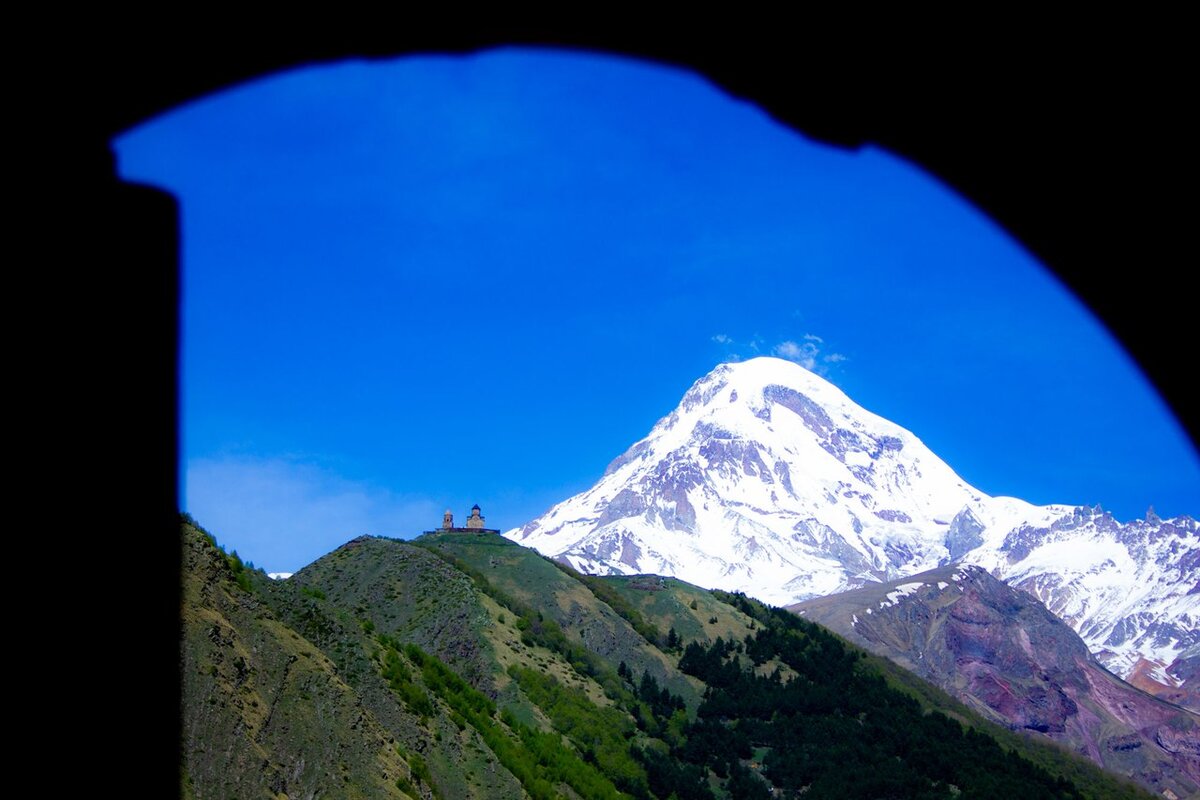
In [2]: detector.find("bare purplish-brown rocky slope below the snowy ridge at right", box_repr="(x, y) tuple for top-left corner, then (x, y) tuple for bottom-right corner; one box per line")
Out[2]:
(792, 566), (1200, 798)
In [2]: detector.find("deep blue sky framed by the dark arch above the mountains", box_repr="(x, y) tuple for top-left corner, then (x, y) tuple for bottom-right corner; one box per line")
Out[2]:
(114, 49), (1200, 571)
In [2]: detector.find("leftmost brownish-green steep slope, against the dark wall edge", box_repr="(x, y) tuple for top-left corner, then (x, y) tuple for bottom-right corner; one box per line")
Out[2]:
(181, 525), (409, 800)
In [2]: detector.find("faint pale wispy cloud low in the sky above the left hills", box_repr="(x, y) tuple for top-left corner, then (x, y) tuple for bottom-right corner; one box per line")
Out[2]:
(185, 457), (443, 572)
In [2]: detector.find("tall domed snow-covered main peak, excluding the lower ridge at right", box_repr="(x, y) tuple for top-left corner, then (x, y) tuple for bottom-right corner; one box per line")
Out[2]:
(508, 357), (995, 603)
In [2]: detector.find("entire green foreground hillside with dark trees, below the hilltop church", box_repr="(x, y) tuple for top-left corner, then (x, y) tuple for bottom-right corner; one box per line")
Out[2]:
(182, 521), (1147, 800)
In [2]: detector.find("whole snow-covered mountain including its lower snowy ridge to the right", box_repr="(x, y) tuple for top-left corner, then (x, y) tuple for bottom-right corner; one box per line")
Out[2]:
(505, 357), (1200, 686)
